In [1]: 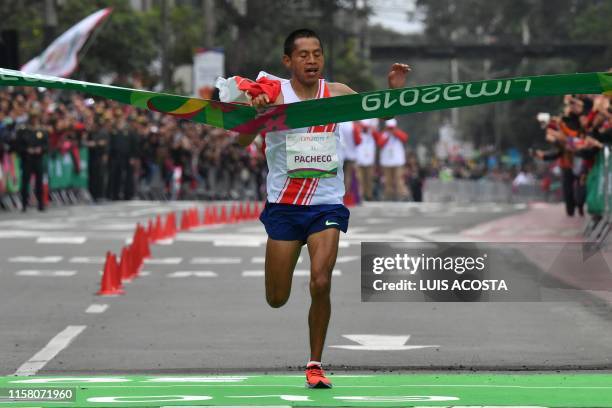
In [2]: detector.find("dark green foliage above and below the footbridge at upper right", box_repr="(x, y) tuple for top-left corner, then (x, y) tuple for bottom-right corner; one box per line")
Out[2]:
(409, 0), (612, 150)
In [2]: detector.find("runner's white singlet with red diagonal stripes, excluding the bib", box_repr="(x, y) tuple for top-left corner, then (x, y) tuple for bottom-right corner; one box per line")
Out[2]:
(264, 79), (344, 205)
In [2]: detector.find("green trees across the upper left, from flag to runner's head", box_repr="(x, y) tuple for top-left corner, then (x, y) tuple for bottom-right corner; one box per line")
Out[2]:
(8, 0), (373, 90)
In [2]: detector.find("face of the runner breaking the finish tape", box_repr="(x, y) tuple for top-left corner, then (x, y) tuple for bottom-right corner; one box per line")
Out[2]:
(283, 37), (325, 86)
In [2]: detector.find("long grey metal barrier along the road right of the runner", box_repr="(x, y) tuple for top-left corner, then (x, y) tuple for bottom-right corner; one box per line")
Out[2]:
(423, 178), (550, 203)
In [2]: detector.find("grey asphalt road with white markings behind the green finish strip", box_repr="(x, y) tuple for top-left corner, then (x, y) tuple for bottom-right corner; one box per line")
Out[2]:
(0, 202), (612, 375)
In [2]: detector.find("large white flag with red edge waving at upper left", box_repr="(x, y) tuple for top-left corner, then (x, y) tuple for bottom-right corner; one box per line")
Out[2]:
(21, 7), (112, 78)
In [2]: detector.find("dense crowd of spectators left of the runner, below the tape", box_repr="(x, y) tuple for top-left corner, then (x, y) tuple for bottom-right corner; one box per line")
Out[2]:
(0, 87), (265, 206)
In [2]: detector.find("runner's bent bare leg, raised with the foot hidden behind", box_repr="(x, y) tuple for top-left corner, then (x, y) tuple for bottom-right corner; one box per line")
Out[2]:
(265, 238), (302, 308)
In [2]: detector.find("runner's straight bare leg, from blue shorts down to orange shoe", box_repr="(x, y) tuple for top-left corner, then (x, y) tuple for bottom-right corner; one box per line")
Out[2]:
(307, 228), (340, 361)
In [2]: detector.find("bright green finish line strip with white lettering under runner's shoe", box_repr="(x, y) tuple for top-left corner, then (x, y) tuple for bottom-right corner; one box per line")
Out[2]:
(0, 373), (612, 407)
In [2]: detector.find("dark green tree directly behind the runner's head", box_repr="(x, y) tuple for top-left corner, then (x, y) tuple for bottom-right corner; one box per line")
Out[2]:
(216, 0), (373, 90)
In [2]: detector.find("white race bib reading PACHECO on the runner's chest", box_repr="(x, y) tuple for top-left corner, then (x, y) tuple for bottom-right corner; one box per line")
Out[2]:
(286, 132), (338, 178)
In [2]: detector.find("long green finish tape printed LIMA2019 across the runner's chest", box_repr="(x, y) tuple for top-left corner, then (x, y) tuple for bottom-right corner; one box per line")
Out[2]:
(0, 69), (612, 133)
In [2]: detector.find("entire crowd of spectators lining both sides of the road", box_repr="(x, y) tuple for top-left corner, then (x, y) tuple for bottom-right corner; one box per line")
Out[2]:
(0, 83), (612, 210)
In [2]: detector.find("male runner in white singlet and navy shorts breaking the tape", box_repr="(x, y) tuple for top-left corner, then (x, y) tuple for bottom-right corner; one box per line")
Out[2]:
(238, 29), (410, 388)
